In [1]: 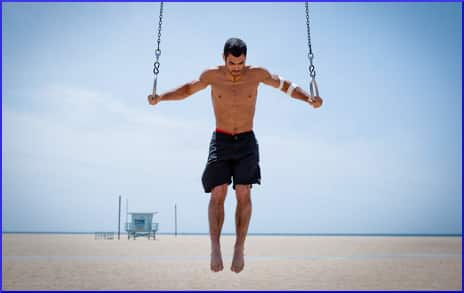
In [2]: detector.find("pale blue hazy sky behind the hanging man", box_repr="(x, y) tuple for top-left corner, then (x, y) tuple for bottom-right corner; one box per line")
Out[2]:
(2, 3), (462, 233)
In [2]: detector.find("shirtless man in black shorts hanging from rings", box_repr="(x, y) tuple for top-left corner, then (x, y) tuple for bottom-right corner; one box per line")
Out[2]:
(148, 38), (322, 273)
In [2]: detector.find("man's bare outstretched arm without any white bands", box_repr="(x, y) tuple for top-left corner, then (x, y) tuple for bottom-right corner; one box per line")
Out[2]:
(148, 70), (211, 105)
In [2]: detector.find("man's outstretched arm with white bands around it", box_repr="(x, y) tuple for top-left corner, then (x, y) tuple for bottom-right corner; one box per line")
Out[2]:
(260, 68), (322, 108)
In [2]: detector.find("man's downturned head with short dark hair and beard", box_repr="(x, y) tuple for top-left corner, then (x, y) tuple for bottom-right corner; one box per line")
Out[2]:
(223, 38), (247, 76)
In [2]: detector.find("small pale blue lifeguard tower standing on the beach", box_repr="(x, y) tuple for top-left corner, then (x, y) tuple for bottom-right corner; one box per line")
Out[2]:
(126, 212), (158, 240)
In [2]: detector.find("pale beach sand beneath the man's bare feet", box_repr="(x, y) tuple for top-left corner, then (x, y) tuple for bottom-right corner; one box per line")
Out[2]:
(2, 234), (462, 290)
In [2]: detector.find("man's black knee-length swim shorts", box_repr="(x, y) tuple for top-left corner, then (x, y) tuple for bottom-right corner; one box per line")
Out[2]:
(201, 131), (261, 193)
